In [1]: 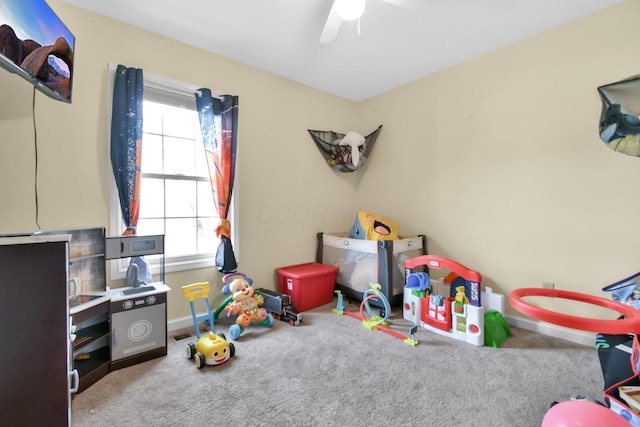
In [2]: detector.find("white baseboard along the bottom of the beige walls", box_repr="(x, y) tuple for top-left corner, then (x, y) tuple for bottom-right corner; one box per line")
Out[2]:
(167, 316), (596, 348)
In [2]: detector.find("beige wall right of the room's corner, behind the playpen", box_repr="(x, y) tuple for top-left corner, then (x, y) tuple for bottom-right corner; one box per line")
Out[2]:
(358, 0), (640, 315)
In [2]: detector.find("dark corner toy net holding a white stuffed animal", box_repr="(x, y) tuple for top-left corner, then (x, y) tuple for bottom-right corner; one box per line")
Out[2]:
(308, 125), (382, 172)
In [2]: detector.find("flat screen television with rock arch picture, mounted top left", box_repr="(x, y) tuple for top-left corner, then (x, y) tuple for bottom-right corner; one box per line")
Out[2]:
(0, 0), (75, 102)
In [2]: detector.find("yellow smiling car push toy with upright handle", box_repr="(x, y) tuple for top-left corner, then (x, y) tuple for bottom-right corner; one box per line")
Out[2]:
(181, 282), (236, 369)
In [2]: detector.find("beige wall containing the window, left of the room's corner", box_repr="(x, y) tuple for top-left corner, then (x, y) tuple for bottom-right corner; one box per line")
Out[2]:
(0, 0), (357, 319)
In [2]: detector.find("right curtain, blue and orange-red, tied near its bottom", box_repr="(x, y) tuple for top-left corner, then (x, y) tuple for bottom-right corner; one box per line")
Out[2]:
(196, 88), (238, 273)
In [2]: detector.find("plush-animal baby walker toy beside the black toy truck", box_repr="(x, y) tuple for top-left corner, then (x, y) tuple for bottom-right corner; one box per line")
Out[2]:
(222, 273), (274, 340)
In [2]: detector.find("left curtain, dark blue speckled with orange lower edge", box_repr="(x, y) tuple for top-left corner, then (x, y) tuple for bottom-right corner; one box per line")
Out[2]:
(111, 65), (144, 235)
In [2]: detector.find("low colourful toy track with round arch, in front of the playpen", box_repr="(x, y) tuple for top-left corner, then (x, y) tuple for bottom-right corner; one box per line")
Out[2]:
(333, 283), (418, 346)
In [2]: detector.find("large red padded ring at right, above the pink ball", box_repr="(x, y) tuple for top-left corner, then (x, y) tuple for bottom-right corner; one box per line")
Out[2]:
(509, 288), (640, 335)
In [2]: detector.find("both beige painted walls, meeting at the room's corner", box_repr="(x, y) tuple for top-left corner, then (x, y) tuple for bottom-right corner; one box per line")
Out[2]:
(0, 0), (640, 326)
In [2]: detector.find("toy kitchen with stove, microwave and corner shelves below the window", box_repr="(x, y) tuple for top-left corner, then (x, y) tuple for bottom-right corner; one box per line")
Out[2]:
(66, 228), (170, 392)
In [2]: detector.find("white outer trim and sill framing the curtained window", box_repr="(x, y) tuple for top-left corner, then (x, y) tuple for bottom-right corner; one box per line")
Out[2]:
(107, 64), (239, 280)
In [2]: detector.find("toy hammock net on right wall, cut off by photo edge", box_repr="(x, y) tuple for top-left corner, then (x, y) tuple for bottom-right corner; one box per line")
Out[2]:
(598, 75), (640, 157)
